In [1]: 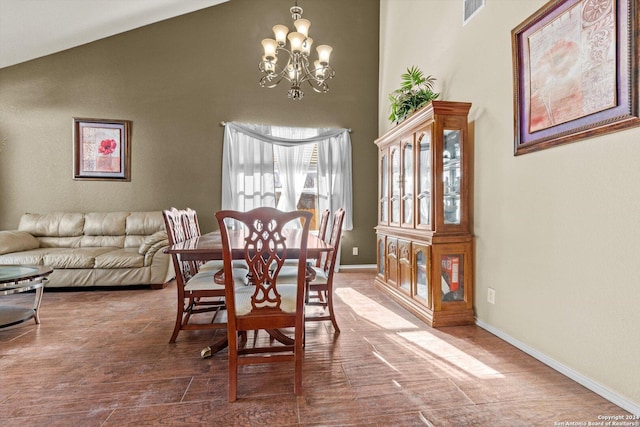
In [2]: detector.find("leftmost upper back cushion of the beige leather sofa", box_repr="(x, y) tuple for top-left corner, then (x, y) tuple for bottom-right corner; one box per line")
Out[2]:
(18, 213), (84, 237)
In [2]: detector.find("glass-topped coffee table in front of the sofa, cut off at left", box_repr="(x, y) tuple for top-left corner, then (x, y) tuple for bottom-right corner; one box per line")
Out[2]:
(0, 265), (53, 328)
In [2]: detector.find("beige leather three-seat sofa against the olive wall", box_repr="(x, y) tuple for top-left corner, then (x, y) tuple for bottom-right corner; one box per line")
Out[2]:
(0, 211), (175, 288)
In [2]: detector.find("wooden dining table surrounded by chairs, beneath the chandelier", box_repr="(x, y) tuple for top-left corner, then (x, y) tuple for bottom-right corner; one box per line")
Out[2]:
(165, 228), (333, 359)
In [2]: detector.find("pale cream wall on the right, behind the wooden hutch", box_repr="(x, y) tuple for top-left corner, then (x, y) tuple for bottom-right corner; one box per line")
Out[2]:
(379, 0), (640, 410)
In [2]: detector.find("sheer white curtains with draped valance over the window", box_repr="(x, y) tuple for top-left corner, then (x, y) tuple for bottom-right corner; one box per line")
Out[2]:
(222, 122), (353, 230)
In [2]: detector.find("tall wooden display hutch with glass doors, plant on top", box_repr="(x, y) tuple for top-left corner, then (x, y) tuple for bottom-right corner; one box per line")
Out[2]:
(375, 101), (474, 327)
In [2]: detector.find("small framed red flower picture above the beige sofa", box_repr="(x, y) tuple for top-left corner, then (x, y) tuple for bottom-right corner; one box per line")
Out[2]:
(73, 118), (131, 181)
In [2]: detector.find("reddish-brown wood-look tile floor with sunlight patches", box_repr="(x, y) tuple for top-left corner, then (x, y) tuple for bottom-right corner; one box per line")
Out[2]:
(0, 270), (627, 427)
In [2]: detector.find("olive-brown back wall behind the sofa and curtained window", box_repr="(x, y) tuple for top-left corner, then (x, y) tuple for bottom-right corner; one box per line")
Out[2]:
(0, 0), (379, 264)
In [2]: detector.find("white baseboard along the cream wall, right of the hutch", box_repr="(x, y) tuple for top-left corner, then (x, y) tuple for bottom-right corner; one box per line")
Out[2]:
(476, 319), (640, 415)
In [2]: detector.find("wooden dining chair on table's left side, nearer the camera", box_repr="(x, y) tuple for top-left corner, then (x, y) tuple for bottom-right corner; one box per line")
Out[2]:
(162, 208), (227, 343)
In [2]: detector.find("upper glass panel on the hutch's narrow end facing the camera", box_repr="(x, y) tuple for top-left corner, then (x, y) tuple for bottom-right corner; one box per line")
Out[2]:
(442, 130), (462, 224)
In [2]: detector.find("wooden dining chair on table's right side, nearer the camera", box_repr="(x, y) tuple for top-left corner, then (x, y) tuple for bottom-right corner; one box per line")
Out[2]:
(306, 208), (345, 333)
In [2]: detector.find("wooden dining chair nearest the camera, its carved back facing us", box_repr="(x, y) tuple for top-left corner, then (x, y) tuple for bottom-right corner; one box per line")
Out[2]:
(216, 207), (313, 402)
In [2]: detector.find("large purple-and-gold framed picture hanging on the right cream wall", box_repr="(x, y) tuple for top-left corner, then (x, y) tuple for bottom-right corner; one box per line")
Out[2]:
(511, 0), (640, 155)
